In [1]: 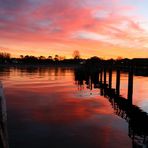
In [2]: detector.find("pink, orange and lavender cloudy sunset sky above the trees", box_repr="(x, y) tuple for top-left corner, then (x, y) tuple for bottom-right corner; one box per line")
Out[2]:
(0, 0), (148, 59)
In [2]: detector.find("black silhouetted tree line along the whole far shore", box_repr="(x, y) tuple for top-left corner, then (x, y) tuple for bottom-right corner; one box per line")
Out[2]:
(0, 50), (148, 67)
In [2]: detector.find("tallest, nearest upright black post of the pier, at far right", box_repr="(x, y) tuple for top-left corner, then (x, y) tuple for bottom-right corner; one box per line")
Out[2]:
(127, 66), (133, 104)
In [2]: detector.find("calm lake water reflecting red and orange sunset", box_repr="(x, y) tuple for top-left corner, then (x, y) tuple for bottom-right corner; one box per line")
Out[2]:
(0, 68), (148, 148)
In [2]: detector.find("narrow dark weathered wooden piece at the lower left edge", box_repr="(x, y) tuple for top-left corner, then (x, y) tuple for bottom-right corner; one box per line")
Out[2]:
(0, 82), (9, 148)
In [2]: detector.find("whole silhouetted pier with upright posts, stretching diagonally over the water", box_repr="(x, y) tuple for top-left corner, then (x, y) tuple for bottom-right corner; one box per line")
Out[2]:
(75, 67), (148, 147)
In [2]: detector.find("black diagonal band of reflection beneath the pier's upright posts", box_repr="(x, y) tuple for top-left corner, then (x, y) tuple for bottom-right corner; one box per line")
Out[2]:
(75, 69), (148, 147)
